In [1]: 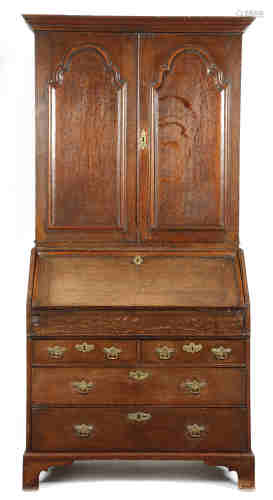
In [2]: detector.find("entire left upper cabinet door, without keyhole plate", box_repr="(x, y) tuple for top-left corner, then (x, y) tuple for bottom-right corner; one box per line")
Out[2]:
(36, 32), (137, 248)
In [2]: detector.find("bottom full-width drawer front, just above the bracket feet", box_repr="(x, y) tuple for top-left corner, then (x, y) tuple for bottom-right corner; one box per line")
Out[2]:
(32, 406), (248, 451)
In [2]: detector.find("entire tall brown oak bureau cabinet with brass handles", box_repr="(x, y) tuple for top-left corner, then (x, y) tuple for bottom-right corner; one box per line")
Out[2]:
(23, 15), (254, 488)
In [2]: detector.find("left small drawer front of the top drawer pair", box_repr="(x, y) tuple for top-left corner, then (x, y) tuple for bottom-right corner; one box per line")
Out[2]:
(32, 339), (137, 366)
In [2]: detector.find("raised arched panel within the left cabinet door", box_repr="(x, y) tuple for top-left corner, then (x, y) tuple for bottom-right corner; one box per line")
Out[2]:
(48, 44), (127, 231)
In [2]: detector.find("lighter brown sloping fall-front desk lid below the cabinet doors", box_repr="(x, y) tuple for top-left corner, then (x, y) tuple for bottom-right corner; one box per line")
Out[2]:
(33, 254), (243, 307)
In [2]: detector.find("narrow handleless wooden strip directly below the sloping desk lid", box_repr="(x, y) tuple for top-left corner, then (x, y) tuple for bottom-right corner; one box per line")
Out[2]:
(32, 310), (245, 336)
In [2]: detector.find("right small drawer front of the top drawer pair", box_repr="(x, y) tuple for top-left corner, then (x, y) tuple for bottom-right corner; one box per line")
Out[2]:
(141, 338), (246, 365)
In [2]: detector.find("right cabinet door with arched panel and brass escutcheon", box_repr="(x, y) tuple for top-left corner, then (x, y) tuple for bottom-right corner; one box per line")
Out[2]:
(139, 34), (238, 247)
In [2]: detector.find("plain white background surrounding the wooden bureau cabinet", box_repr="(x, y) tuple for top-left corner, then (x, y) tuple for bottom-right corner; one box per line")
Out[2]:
(0, 0), (273, 500)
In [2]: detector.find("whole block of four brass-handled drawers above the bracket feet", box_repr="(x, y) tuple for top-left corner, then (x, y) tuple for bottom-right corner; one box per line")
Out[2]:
(32, 336), (248, 451)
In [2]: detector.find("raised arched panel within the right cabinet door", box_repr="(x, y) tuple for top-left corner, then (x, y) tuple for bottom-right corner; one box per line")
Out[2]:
(144, 46), (229, 239)
